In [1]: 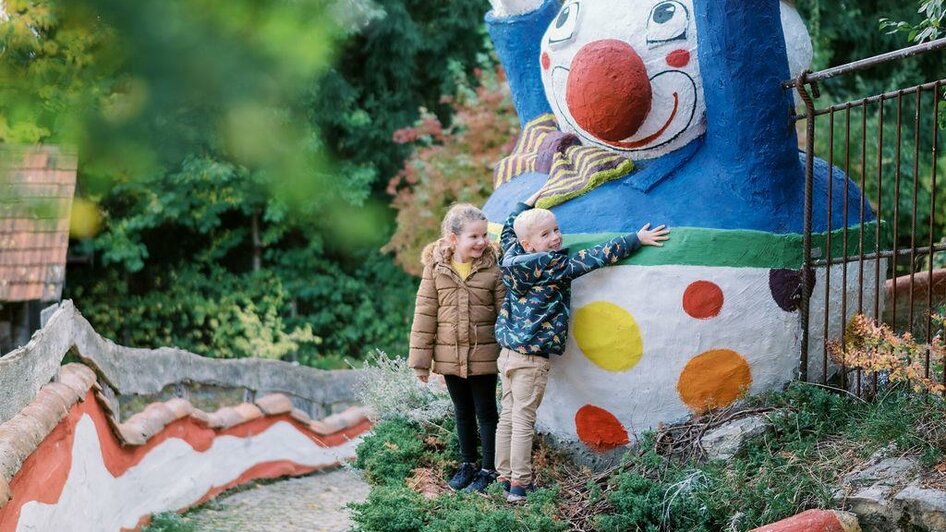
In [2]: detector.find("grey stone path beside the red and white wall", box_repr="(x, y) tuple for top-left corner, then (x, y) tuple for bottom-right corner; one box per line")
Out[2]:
(185, 468), (368, 532)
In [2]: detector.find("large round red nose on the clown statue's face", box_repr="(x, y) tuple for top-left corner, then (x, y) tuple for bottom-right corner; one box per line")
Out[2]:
(565, 39), (651, 142)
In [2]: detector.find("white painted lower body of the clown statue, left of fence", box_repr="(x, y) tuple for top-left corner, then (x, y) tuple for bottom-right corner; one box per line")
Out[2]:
(539, 266), (798, 439)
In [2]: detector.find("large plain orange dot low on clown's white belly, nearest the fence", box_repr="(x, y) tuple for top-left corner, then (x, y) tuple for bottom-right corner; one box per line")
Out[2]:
(677, 349), (752, 414)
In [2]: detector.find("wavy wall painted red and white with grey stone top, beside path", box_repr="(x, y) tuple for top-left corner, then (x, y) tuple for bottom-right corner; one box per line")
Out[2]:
(0, 301), (371, 532)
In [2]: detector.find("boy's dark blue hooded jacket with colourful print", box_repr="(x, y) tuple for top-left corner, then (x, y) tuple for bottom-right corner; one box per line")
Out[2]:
(496, 203), (640, 357)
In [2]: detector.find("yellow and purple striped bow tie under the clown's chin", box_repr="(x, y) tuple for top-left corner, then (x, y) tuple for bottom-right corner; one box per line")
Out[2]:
(493, 113), (634, 209)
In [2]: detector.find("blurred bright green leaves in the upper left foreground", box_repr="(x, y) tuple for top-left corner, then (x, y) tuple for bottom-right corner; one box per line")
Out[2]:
(0, 0), (350, 216)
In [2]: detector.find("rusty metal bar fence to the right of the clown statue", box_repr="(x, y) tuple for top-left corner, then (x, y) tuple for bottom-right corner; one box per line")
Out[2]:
(783, 39), (946, 395)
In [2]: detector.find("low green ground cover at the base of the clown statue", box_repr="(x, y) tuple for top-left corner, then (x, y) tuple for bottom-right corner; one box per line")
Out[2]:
(353, 383), (946, 531)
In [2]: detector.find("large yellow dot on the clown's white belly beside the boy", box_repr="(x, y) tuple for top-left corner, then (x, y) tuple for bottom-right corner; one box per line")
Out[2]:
(572, 301), (644, 372)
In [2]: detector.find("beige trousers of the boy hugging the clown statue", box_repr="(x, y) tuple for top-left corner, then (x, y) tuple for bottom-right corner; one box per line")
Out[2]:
(496, 349), (549, 486)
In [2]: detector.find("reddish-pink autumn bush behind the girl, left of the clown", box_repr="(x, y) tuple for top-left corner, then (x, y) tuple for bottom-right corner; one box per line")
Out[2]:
(384, 70), (519, 275)
